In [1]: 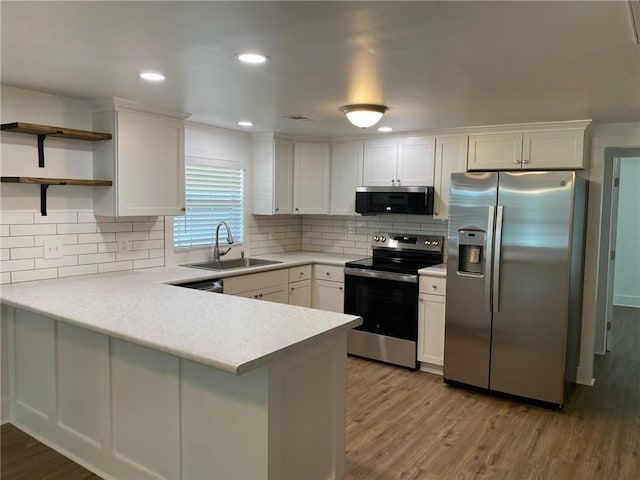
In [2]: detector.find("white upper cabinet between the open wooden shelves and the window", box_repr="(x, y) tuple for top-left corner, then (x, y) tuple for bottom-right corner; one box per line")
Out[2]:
(89, 98), (187, 216)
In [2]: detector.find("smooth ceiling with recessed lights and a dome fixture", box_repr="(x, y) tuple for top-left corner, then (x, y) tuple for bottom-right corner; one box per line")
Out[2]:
(0, 0), (640, 136)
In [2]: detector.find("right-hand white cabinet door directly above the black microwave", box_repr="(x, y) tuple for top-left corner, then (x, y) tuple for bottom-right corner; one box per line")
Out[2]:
(396, 137), (436, 187)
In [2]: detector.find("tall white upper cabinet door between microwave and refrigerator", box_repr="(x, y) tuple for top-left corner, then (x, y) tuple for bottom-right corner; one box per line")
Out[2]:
(433, 135), (469, 220)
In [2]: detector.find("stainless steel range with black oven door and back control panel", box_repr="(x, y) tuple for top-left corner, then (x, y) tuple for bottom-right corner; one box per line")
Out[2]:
(344, 232), (444, 369)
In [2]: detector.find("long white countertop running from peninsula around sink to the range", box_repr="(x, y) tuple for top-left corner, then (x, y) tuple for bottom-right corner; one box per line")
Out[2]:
(0, 252), (361, 374)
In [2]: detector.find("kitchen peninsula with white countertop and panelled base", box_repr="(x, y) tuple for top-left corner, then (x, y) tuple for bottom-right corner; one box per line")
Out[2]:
(1, 258), (361, 479)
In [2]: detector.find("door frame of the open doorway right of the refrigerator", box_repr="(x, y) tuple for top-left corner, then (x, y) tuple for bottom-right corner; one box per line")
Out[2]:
(594, 147), (640, 355)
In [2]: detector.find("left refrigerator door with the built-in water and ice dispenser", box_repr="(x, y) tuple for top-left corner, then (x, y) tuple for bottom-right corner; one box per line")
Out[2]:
(444, 173), (498, 388)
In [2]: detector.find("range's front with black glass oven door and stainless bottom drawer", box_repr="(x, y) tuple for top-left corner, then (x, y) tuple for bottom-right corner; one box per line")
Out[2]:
(344, 268), (418, 368)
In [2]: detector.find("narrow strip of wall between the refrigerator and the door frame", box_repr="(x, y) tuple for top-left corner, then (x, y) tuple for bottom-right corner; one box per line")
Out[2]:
(578, 123), (640, 385)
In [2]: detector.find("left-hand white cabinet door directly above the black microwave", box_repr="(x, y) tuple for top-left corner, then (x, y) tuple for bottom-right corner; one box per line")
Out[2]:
(363, 139), (398, 187)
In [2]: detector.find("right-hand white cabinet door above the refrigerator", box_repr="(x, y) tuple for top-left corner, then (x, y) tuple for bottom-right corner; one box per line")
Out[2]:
(522, 129), (585, 170)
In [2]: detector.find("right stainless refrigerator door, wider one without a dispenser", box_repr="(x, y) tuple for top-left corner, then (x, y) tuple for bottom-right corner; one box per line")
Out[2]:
(489, 172), (575, 404)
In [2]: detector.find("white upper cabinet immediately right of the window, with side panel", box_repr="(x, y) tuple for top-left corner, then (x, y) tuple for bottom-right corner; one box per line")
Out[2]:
(251, 134), (293, 215)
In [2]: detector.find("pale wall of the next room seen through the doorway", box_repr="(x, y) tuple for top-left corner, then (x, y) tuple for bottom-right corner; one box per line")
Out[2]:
(613, 158), (640, 308)
